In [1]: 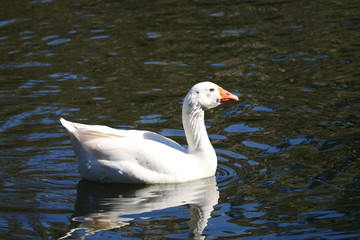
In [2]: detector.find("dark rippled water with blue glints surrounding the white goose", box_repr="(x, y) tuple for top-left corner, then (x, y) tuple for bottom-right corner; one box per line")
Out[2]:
(0, 0), (360, 239)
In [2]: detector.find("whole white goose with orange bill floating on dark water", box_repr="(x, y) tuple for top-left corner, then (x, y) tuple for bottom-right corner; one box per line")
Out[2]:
(60, 82), (238, 184)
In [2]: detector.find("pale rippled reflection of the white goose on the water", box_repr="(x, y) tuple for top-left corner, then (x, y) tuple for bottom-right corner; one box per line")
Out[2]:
(62, 177), (219, 239)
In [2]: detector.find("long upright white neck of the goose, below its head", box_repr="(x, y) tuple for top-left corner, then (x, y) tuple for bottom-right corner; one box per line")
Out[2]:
(182, 91), (216, 155)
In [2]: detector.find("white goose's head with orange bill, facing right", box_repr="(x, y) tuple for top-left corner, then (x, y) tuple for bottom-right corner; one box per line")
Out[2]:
(185, 82), (239, 110)
